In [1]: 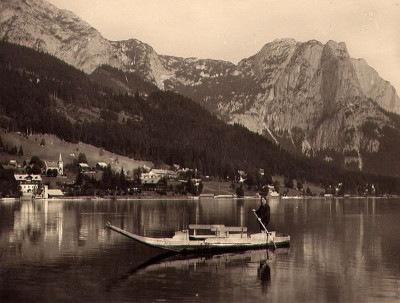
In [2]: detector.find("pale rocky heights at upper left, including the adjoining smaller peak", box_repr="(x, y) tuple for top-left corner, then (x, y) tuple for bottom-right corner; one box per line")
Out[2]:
(0, 0), (169, 88)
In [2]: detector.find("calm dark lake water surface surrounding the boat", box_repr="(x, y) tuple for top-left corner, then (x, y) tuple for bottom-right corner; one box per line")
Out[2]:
(0, 198), (400, 302)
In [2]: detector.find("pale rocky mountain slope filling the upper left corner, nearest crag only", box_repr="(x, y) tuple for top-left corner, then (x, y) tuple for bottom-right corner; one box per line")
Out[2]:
(0, 0), (113, 72)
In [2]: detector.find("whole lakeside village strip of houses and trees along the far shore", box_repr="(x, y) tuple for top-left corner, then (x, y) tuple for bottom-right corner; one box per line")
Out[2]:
(0, 153), (382, 200)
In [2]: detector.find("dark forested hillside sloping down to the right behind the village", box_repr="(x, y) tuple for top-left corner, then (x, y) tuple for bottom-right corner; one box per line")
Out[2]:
(0, 42), (399, 193)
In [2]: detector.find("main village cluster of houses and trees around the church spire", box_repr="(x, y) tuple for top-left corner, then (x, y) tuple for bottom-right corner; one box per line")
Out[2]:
(2, 153), (202, 199)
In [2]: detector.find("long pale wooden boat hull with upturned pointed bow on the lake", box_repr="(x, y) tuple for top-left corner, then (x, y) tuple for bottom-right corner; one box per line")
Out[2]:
(106, 224), (290, 253)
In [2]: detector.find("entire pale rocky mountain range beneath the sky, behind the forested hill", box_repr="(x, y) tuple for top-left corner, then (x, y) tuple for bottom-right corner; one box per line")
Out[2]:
(0, 0), (400, 177)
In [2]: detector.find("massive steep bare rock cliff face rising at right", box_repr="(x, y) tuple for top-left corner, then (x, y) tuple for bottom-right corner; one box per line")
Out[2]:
(230, 40), (391, 168)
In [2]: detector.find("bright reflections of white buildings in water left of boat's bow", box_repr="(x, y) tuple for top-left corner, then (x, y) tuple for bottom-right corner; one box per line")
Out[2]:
(0, 200), (123, 261)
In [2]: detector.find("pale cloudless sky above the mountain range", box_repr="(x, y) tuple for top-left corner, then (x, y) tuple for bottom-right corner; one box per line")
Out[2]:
(48, 0), (400, 94)
